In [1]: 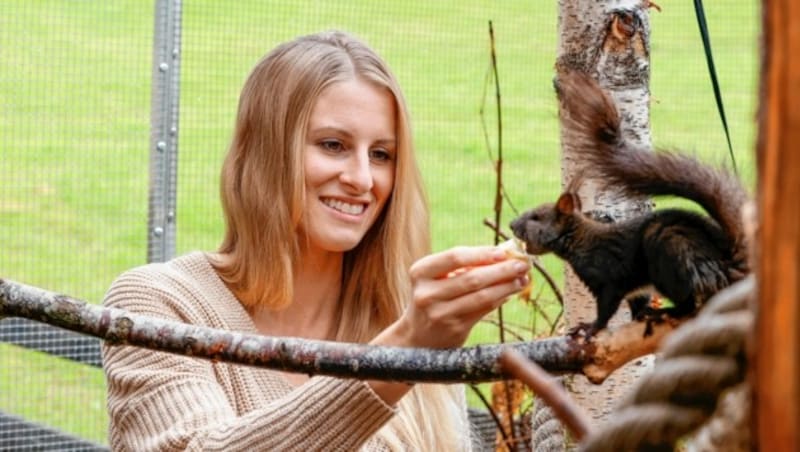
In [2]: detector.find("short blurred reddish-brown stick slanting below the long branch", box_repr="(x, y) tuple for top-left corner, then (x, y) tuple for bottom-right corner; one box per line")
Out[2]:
(500, 348), (591, 441)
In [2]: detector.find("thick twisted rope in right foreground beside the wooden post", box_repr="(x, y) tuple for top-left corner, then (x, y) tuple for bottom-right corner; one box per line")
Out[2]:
(579, 276), (755, 452)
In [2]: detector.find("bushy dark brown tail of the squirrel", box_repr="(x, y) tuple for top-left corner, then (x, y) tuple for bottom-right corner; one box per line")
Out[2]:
(556, 72), (748, 251)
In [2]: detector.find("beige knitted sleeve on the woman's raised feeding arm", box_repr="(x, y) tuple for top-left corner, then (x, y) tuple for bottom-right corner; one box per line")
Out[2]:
(103, 271), (394, 451)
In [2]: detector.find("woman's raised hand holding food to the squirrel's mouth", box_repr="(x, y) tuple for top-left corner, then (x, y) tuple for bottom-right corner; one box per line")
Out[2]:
(375, 246), (530, 348)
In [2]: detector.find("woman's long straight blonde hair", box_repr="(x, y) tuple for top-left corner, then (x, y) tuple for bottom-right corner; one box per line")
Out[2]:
(215, 31), (469, 450)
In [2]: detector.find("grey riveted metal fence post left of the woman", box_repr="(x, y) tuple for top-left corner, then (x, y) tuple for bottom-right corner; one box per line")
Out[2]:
(147, 0), (181, 262)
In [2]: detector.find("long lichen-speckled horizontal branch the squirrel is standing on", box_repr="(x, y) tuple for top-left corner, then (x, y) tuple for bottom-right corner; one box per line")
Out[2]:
(0, 280), (676, 383)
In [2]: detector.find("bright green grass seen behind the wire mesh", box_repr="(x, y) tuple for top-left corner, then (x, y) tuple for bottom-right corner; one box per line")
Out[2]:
(0, 0), (759, 442)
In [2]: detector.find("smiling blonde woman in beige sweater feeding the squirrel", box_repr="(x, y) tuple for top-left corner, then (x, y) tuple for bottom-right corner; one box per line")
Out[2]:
(104, 32), (528, 451)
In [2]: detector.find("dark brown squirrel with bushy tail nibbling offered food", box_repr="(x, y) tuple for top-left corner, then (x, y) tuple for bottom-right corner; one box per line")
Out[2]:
(511, 72), (750, 336)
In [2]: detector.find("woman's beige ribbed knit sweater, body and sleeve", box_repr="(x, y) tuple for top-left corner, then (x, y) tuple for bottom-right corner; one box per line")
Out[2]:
(103, 252), (395, 452)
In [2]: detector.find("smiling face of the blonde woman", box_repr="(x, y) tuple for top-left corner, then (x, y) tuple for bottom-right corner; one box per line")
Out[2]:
(298, 79), (397, 252)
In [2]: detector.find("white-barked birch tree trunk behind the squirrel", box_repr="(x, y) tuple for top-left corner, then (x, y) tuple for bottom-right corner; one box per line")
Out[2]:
(534, 0), (653, 450)
